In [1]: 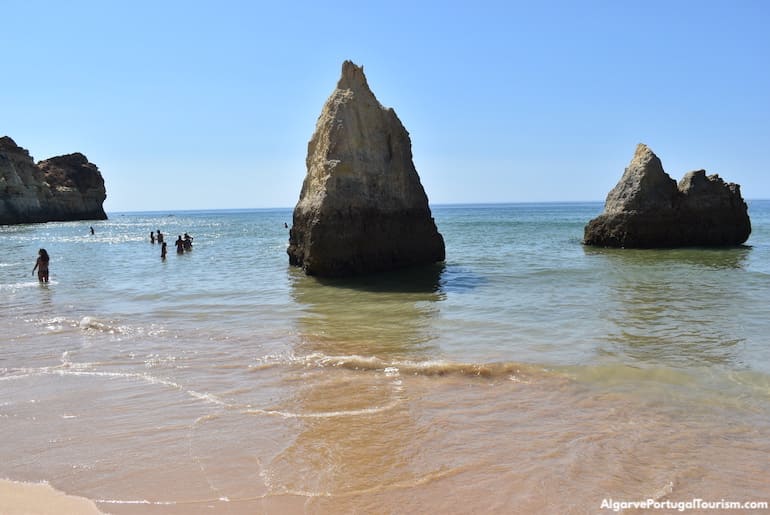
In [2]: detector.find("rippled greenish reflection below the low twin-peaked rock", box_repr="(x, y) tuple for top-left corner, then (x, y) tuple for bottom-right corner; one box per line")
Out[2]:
(586, 247), (751, 368)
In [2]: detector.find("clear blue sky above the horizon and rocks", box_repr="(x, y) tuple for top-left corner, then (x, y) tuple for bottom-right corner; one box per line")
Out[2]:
(0, 0), (770, 213)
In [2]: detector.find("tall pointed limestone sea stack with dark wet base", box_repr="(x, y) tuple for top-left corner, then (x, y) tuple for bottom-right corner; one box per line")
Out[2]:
(287, 61), (445, 277)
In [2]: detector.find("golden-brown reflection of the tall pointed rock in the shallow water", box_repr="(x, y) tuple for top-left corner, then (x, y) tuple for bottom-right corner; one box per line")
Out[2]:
(270, 265), (460, 511)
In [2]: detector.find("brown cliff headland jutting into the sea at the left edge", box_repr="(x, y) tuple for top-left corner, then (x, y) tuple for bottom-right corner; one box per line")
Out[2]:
(0, 136), (107, 225)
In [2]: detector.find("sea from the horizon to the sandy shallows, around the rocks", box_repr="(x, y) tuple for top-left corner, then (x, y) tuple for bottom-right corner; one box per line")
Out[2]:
(0, 201), (770, 514)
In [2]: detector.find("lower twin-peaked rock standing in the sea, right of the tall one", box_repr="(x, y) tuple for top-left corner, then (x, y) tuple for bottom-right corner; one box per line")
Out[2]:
(583, 144), (751, 248)
